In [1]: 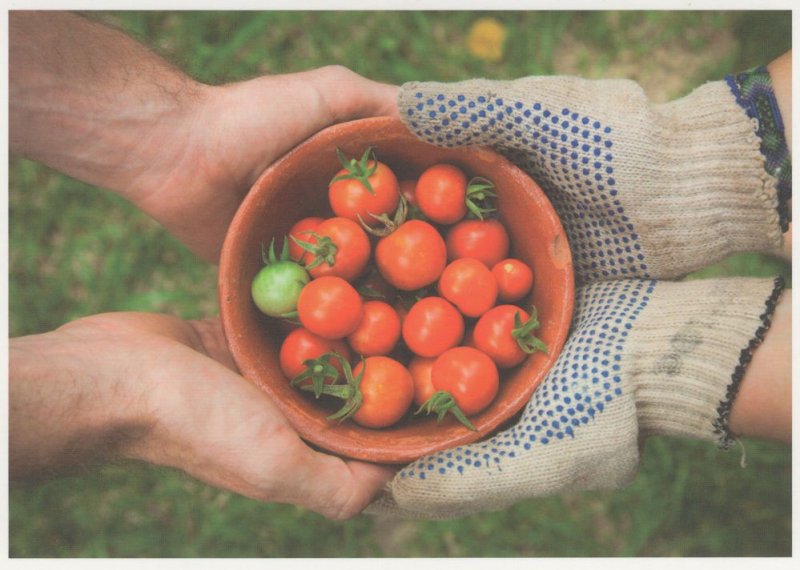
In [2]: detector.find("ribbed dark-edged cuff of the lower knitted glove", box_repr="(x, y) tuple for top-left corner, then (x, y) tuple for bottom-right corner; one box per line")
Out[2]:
(623, 277), (784, 448)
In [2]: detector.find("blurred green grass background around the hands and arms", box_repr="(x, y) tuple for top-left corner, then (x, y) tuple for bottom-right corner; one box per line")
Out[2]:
(9, 11), (792, 557)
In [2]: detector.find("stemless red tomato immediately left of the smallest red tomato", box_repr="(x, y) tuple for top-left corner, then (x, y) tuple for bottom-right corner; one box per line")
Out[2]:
(439, 257), (497, 317)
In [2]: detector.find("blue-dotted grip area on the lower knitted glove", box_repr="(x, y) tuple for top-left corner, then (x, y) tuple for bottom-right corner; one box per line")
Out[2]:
(399, 280), (657, 479)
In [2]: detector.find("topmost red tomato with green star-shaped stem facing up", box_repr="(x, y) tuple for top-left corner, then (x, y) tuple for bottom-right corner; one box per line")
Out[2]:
(328, 153), (400, 226)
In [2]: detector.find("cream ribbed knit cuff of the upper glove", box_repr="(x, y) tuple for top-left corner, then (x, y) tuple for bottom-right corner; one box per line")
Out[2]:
(629, 81), (782, 275)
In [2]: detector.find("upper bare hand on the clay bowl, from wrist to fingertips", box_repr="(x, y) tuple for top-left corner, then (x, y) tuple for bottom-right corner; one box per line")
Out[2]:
(133, 66), (397, 261)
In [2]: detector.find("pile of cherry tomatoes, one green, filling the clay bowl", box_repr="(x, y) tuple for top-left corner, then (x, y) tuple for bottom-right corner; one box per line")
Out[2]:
(252, 148), (547, 429)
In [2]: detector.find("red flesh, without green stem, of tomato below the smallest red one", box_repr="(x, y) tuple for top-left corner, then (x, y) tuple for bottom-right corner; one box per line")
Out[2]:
(473, 305), (530, 368)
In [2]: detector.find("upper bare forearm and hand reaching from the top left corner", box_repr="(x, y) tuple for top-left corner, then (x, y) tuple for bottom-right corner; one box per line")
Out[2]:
(9, 11), (397, 261)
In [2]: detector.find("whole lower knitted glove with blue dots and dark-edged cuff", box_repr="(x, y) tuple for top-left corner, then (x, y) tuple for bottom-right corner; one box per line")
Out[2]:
(368, 278), (781, 519)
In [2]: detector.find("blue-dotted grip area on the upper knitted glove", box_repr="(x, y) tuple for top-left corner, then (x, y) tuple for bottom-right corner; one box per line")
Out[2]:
(405, 91), (650, 284)
